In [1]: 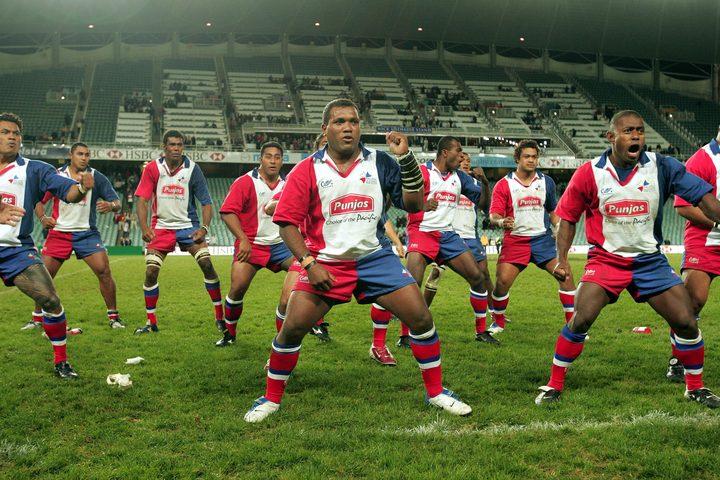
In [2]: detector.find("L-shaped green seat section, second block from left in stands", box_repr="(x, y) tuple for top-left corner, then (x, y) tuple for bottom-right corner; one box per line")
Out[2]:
(83, 61), (152, 143)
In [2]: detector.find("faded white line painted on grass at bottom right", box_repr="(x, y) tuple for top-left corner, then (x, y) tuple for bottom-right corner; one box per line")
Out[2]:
(383, 410), (720, 437)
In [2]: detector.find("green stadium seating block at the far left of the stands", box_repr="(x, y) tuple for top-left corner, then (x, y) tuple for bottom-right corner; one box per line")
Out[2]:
(0, 68), (84, 137)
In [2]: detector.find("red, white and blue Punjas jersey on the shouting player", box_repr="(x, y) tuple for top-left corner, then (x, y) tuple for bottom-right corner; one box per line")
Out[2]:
(555, 150), (712, 257)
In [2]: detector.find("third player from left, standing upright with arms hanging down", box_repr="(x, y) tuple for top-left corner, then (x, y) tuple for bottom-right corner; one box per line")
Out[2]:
(135, 130), (225, 334)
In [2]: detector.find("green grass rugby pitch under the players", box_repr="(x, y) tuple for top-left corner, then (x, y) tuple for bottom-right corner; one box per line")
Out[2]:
(0, 253), (720, 480)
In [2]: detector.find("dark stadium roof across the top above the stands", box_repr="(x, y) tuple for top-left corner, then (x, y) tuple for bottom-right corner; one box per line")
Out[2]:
(5, 0), (720, 63)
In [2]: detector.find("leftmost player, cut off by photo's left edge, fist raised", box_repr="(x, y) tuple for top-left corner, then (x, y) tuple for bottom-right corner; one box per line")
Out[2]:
(0, 113), (94, 379)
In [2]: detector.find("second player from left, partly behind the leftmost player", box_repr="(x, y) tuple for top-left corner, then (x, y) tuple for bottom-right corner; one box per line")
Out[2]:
(27, 143), (125, 328)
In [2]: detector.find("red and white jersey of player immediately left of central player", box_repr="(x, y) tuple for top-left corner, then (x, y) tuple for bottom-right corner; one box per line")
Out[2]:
(220, 168), (285, 245)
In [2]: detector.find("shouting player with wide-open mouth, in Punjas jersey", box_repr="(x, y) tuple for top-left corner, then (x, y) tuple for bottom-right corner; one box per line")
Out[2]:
(535, 110), (720, 408)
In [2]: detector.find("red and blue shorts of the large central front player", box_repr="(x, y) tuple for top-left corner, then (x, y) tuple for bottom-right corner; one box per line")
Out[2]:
(294, 248), (415, 303)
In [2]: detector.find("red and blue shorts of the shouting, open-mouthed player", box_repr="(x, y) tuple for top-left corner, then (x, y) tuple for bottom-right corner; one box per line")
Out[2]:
(581, 247), (682, 303)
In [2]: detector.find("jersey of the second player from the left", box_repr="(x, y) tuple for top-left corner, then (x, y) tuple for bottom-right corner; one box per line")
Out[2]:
(42, 165), (118, 232)
